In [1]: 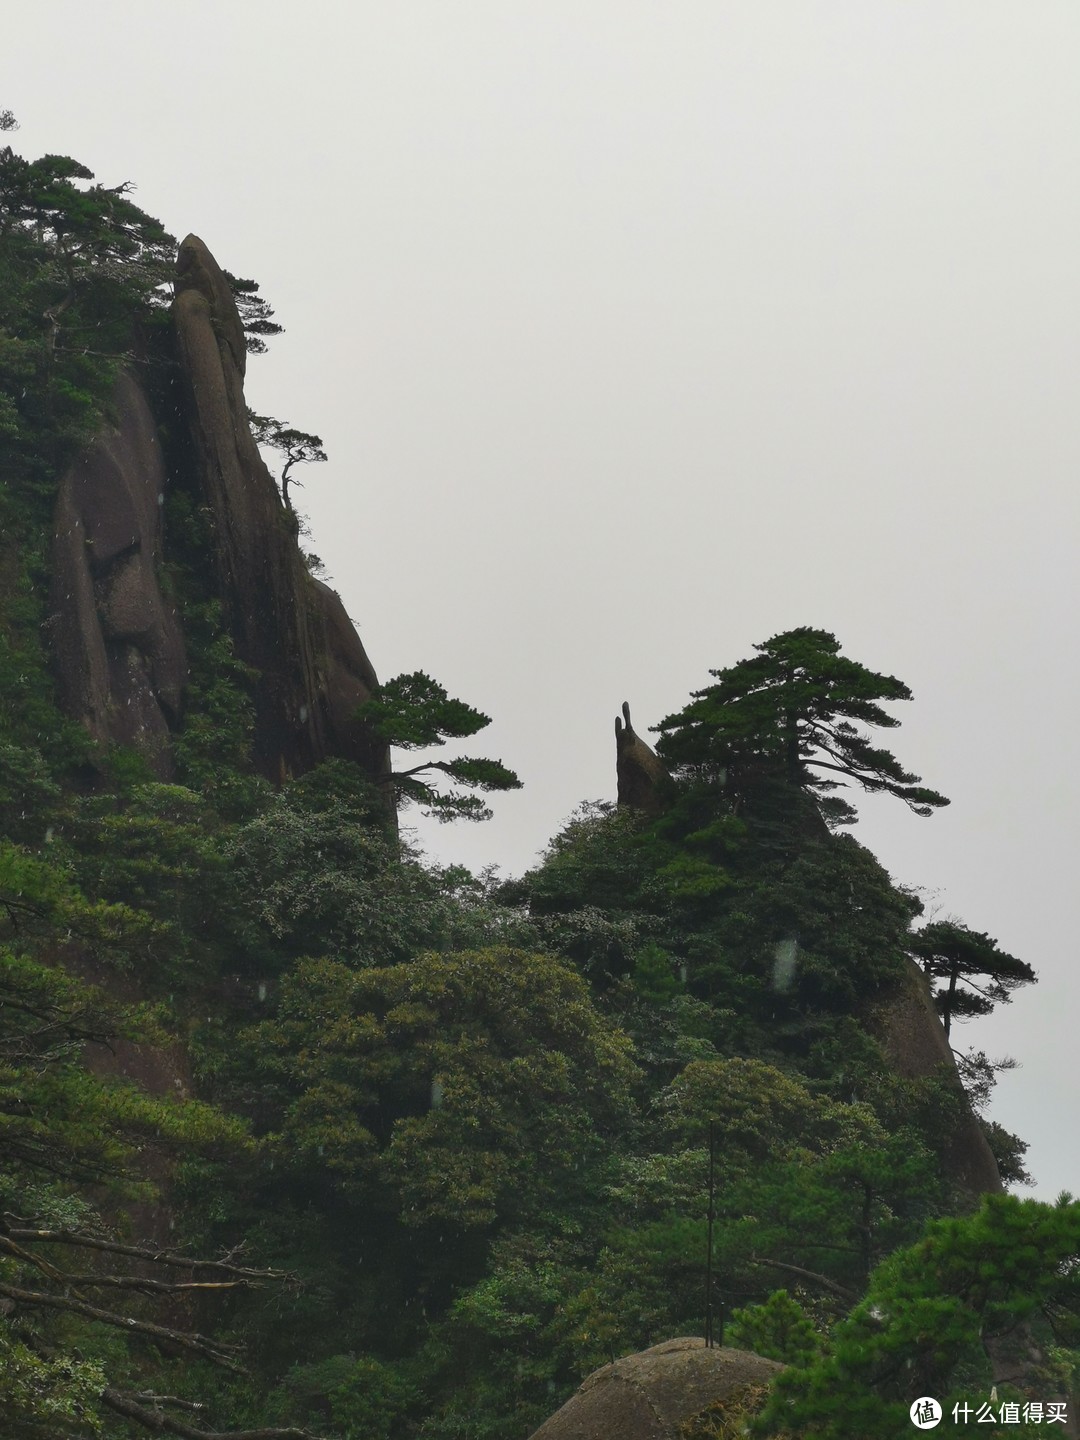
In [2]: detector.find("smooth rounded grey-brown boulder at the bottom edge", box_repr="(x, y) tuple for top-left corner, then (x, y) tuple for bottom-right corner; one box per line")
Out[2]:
(531, 1336), (783, 1440)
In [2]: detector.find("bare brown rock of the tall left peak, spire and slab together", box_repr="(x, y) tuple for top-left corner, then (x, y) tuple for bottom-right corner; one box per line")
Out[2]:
(48, 236), (387, 780)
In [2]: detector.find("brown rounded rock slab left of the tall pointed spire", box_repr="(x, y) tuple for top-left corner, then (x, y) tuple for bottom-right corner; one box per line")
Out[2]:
(50, 376), (187, 778)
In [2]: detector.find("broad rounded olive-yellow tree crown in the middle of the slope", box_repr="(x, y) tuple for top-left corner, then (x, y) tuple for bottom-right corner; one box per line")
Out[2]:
(249, 950), (634, 1230)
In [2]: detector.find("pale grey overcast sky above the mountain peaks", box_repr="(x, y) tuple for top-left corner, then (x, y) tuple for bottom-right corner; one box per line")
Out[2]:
(8, 0), (1080, 1198)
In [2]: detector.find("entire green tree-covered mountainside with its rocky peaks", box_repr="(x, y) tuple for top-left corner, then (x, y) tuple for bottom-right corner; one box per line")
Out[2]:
(0, 124), (1080, 1440)
